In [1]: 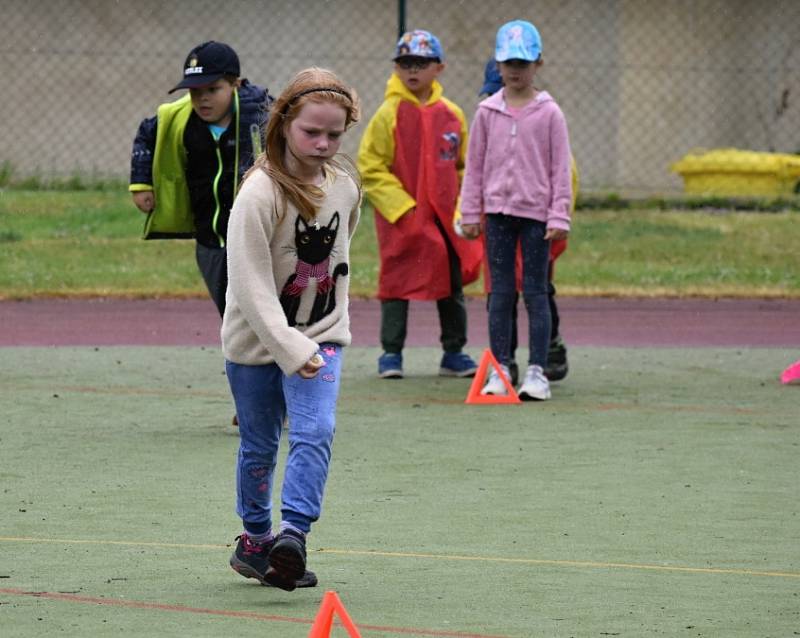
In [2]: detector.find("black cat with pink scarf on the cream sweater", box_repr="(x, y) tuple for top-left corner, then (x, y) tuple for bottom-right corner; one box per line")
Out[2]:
(280, 211), (349, 326)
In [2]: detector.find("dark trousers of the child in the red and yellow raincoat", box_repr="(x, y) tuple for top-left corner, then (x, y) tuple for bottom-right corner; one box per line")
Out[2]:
(381, 225), (467, 354)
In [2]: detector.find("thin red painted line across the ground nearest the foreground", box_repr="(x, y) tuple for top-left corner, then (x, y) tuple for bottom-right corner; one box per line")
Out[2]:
(0, 587), (508, 638)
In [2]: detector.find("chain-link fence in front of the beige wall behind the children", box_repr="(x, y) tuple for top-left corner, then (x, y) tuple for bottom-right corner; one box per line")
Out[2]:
(0, 0), (800, 192)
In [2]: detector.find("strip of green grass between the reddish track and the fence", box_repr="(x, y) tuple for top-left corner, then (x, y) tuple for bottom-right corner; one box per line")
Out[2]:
(0, 190), (800, 298)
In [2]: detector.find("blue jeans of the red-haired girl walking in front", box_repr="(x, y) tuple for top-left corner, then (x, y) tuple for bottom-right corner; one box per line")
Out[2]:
(225, 343), (342, 534)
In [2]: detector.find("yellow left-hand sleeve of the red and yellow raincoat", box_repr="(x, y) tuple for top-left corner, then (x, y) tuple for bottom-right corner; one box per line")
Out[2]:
(358, 102), (417, 224)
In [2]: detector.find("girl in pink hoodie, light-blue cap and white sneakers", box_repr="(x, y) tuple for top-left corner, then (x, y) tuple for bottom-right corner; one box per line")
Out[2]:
(461, 20), (572, 401)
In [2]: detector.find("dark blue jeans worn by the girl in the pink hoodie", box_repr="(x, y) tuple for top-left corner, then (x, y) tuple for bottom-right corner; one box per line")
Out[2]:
(485, 213), (550, 368)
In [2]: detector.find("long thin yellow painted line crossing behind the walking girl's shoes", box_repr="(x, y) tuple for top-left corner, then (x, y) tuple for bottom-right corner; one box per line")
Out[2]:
(0, 536), (800, 579)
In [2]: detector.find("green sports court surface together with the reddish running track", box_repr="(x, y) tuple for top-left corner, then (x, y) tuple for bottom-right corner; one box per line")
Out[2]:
(0, 298), (800, 638)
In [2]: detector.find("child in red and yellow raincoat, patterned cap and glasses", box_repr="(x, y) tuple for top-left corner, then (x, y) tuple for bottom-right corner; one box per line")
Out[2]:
(358, 31), (483, 378)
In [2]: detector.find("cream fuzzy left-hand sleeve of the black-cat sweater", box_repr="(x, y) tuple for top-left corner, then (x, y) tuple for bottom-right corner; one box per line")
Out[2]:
(227, 171), (318, 375)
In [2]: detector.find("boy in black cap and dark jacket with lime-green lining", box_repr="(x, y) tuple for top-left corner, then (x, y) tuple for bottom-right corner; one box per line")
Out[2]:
(129, 41), (272, 316)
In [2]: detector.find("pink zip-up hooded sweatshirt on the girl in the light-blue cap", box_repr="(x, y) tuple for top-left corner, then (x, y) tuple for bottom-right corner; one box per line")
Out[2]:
(461, 89), (572, 231)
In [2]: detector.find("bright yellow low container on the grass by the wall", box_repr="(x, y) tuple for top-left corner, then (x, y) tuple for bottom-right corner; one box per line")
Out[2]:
(670, 148), (800, 197)
